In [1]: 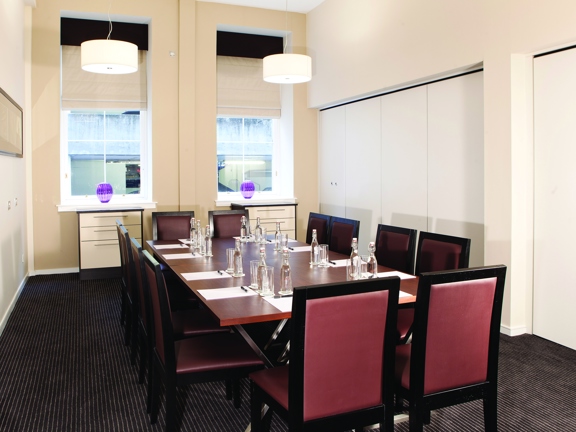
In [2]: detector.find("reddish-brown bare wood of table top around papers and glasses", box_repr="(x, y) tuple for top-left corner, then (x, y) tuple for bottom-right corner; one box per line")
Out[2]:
(148, 239), (418, 326)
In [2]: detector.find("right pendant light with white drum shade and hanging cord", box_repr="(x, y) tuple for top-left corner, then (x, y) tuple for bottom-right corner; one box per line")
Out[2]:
(262, 0), (312, 84)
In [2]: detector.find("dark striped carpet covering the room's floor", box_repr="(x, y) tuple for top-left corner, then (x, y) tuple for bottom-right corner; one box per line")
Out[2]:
(0, 274), (576, 432)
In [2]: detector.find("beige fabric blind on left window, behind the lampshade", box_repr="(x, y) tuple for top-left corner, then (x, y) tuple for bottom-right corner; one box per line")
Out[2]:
(62, 45), (147, 110)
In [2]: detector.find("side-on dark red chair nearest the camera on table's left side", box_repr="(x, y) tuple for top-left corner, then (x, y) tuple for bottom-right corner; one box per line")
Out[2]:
(143, 251), (264, 431)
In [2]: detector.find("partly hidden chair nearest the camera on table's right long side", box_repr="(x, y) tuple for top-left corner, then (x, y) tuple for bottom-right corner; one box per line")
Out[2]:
(398, 231), (470, 343)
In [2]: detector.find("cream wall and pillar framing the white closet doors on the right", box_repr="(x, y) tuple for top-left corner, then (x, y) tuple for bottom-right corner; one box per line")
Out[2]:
(307, 0), (576, 334)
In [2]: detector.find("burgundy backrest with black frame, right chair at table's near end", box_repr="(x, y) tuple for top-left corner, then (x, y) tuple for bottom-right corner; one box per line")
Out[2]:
(410, 265), (506, 395)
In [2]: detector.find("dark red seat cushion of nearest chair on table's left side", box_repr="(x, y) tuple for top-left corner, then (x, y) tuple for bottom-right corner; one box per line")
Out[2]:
(174, 333), (264, 374)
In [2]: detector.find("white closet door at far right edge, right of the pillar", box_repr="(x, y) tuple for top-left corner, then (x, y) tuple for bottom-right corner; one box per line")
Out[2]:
(533, 49), (576, 349)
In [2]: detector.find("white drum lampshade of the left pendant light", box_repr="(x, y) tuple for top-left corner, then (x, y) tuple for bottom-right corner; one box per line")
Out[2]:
(80, 39), (138, 74)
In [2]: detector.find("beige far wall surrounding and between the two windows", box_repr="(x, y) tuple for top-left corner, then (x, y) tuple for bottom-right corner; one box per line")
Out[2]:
(32, 0), (317, 271)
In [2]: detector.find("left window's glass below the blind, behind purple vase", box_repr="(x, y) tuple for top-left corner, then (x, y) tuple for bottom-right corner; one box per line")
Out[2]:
(62, 110), (146, 199)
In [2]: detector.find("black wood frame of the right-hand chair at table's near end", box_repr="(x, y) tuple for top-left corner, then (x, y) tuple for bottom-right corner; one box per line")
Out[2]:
(396, 265), (506, 432)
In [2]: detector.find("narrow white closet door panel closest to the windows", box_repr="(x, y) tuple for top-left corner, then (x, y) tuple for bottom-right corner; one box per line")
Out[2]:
(318, 106), (346, 217)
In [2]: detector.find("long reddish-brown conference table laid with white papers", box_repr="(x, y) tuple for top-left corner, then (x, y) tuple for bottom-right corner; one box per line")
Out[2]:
(148, 238), (418, 326)
